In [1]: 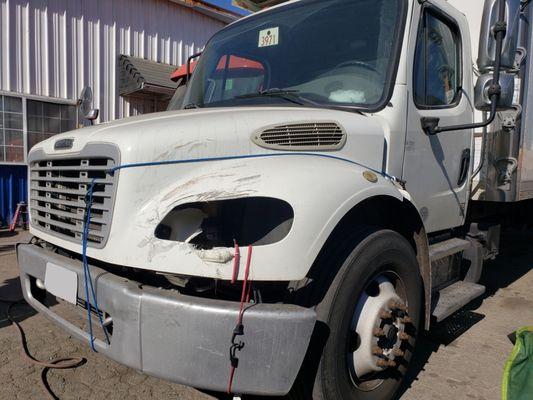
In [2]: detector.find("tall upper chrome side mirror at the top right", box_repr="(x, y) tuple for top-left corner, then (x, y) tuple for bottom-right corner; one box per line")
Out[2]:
(477, 0), (522, 74)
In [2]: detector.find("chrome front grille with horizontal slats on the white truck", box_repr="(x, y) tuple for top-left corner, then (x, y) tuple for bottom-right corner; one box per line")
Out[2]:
(29, 157), (116, 247)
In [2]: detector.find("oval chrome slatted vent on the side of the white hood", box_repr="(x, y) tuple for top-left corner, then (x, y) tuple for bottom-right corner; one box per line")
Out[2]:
(252, 122), (346, 151)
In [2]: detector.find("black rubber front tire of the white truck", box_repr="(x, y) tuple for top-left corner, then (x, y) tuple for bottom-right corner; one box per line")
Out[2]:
(289, 229), (423, 400)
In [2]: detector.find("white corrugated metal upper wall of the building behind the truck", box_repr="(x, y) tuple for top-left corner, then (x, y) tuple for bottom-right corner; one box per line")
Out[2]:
(0, 0), (224, 121)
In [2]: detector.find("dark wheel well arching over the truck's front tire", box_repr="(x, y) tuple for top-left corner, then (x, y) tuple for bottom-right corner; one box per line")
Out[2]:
(296, 196), (431, 327)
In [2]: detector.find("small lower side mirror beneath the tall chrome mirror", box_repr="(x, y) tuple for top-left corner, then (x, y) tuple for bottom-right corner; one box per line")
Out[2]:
(474, 72), (515, 111)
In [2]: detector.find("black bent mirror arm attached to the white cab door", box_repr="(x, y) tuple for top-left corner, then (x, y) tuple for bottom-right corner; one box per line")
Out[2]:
(420, 0), (507, 136)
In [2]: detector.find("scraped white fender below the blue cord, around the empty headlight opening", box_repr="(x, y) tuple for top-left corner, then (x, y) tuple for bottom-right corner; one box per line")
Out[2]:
(32, 153), (403, 281)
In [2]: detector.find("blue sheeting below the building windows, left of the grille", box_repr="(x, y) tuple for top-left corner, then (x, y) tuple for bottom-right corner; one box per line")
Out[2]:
(0, 165), (28, 226)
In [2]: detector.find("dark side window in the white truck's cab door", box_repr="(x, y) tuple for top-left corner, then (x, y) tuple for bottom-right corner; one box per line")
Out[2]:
(414, 10), (461, 108)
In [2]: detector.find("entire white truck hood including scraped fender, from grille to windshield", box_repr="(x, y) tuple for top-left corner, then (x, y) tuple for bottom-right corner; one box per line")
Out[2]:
(32, 107), (418, 281)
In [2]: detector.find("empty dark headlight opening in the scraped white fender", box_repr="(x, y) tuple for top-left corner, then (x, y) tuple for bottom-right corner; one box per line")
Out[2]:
(155, 197), (294, 250)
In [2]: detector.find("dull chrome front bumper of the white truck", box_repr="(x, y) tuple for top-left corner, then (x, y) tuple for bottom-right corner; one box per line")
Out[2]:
(17, 244), (316, 395)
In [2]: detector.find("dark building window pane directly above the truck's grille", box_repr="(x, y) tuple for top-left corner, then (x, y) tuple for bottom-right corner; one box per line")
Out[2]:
(26, 100), (76, 151)
